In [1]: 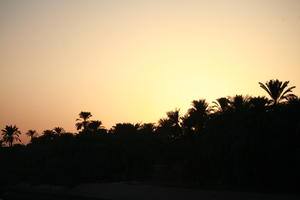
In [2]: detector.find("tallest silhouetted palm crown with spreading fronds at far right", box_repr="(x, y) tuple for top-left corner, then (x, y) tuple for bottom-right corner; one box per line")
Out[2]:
(259, 79), (296, 105)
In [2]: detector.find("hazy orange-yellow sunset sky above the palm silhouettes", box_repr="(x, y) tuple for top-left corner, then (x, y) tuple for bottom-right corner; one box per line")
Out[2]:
(0, 0), (300, 143)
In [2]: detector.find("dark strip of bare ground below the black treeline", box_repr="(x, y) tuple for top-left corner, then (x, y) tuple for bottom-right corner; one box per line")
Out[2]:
(0, 182), (300, 200)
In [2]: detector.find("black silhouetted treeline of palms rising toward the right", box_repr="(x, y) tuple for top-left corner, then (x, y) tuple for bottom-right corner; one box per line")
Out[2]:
(0, 80), (300, 191)
